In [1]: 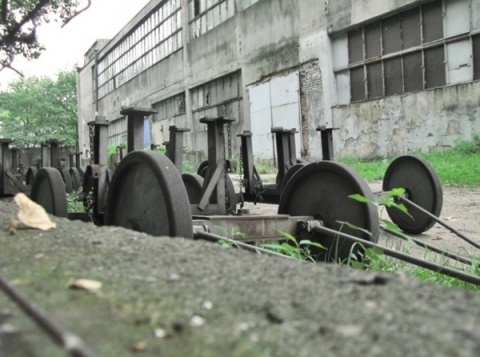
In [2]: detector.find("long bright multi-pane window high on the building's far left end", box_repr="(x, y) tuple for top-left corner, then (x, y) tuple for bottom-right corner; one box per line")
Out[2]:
(98, 0), (183, 98)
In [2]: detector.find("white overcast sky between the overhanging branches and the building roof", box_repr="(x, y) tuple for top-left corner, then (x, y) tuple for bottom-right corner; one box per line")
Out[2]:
(0, 0), (150, 89)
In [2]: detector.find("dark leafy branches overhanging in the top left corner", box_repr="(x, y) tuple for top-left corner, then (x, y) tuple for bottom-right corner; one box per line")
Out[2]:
(0, 0), (91, 73)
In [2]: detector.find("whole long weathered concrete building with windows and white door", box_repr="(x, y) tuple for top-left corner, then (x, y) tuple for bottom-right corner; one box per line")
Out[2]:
(78, 0), (480, 160)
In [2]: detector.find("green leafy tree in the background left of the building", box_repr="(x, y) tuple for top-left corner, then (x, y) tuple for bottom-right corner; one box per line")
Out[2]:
(0, 70), (77, 148)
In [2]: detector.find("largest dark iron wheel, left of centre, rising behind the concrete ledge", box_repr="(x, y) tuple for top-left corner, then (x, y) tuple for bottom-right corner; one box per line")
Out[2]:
(105, 151), (193, 238)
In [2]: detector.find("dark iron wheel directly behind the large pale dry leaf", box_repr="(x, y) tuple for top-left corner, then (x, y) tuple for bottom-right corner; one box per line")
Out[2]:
(30, 167), (68, 217)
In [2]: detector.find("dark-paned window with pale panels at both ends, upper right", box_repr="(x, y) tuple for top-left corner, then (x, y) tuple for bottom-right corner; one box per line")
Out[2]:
(333, 0), (480, 104)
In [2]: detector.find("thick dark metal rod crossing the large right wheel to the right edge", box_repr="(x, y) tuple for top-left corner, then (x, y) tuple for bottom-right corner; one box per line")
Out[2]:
(312, 226), (480, 286)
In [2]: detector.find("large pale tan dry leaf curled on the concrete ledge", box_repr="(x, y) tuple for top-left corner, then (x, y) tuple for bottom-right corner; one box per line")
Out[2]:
(15, 193), (57, 231)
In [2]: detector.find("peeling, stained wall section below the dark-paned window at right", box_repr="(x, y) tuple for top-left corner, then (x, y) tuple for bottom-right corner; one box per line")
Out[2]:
(333, 82), (480, 157)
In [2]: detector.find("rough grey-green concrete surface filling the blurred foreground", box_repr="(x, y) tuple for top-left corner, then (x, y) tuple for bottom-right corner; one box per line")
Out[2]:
(0, 186), (480, 357)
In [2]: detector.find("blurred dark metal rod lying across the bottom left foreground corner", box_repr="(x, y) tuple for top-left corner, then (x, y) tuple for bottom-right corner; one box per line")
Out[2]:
(0, 275), (94, 357)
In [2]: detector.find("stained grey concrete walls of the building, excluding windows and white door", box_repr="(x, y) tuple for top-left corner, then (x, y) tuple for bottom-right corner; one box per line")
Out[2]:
(79, 0), (480, 160)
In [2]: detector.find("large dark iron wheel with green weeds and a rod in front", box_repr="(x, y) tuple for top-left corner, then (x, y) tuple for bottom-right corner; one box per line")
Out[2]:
(278, 161), (380, 262)
